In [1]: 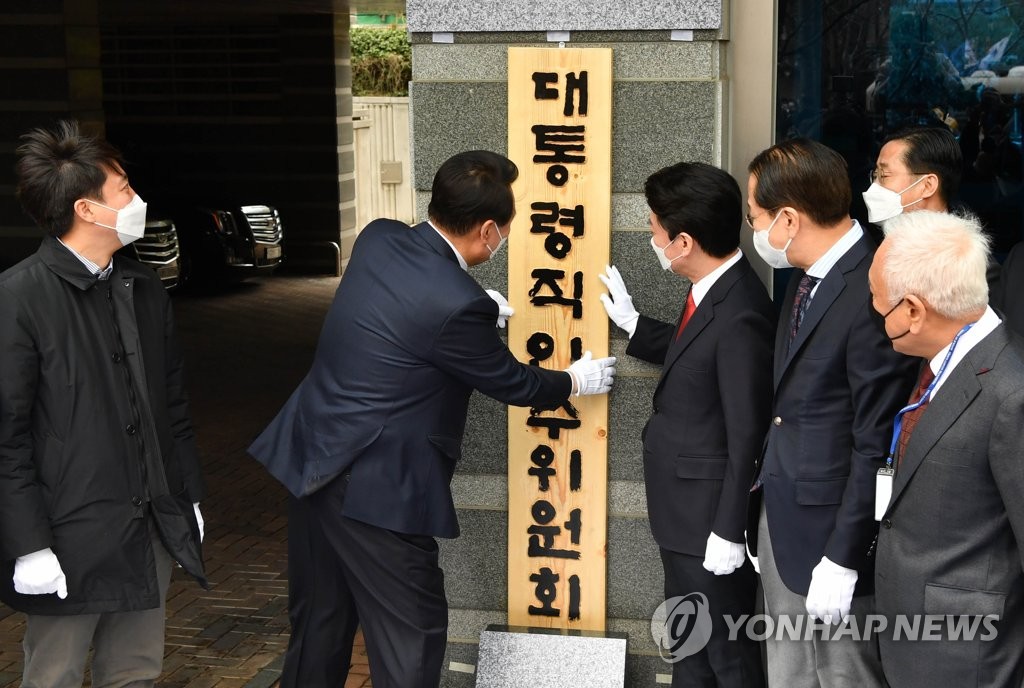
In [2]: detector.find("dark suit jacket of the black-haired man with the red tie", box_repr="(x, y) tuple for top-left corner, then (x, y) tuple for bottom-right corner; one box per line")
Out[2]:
(626, 257), (775, 557)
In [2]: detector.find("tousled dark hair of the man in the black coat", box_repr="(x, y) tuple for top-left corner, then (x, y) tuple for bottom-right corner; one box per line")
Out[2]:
(14, 120), (124, 237)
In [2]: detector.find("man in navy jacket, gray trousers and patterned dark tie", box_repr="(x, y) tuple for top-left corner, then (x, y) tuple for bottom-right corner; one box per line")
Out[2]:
(748, 139), (915, 688)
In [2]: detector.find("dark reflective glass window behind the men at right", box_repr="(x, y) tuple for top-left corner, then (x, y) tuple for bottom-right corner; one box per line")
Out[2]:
(775, 0), (1024, 259)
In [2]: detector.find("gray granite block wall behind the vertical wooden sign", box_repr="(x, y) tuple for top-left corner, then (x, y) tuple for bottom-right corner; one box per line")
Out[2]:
(408, 0), (728, 686)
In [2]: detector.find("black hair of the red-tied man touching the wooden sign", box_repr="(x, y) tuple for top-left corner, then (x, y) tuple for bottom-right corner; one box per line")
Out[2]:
(643, 163), (743, 258)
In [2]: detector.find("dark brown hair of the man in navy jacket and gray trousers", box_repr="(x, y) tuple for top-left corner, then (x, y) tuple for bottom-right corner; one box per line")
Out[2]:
(748, 138), (853, 226)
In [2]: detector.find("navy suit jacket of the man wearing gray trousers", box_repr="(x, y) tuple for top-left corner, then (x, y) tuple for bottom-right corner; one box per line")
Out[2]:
(749, 234), (916, 595)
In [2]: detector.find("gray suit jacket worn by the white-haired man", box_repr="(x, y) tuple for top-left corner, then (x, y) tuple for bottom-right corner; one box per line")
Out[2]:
(874, 325), (1024, 688)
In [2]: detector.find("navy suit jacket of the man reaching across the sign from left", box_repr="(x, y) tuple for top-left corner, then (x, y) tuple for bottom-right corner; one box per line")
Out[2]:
(249, 220), (571, 538)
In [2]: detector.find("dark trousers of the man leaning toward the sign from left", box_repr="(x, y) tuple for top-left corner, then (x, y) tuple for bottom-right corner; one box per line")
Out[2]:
(281, 476), (447, 688)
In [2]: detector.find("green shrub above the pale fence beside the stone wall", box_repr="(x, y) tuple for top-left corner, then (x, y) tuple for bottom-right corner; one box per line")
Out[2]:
(349, 28), (413, 96)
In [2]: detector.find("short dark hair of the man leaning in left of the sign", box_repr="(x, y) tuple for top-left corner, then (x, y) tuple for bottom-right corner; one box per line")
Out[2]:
(427, 151), (519, 235)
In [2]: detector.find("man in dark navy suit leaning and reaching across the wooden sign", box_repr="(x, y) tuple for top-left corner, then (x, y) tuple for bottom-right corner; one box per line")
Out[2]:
(249, 151), (614, 688)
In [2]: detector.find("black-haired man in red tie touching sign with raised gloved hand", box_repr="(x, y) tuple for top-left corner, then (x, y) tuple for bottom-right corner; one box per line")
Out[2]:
(601, 163), (775, 688)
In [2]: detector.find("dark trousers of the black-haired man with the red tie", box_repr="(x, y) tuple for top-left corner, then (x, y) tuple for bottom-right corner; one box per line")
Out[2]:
(662, 548), (765, 688)
